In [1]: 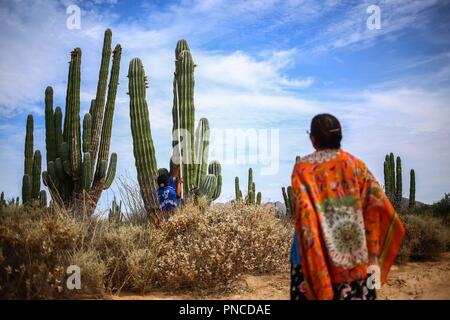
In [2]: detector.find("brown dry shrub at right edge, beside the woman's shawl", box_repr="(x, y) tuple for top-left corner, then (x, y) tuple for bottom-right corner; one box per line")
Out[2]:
(397, 215), (450, 263)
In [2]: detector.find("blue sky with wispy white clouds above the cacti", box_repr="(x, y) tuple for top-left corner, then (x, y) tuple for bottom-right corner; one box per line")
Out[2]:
(0, 0), (450, 207)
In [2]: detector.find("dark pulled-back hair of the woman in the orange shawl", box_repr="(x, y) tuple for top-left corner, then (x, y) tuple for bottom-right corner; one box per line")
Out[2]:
(311, 113), (342, 149)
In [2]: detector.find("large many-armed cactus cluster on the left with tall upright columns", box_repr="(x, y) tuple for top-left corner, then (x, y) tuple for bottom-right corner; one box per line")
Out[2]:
(40, 29), (122, 215)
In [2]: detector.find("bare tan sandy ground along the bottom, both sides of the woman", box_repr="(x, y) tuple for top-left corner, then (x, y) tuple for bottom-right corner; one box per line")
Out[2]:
(107, 252), (450, 300)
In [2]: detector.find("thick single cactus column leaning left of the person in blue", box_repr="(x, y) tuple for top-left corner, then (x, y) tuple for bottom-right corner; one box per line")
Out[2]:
(128, 58), (159, 216)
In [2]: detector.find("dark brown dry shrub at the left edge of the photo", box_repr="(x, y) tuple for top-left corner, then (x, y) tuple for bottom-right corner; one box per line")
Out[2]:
(0, 206), (92, 299)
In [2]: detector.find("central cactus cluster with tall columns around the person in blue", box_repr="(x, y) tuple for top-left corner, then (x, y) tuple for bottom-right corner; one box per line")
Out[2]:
(128, 40), (222, 215)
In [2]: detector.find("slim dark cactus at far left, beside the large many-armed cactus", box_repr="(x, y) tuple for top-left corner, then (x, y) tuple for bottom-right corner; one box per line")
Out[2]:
(22, 115), (46, 204)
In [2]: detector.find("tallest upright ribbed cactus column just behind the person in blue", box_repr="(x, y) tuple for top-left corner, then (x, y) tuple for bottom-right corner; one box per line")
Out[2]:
(172, 40), (196, 194)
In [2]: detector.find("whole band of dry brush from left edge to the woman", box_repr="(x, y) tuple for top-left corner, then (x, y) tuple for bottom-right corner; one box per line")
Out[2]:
(0, 192), (292, 299)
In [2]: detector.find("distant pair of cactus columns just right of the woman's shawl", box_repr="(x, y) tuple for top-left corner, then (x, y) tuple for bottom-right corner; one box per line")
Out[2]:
(384, 152), (416, 211)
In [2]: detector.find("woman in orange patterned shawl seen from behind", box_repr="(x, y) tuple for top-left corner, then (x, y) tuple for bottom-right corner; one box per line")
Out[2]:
(291, 114), (405, 300)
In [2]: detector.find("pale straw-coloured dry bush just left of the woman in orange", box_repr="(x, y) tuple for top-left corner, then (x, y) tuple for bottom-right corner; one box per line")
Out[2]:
(153, 204), (292, 289)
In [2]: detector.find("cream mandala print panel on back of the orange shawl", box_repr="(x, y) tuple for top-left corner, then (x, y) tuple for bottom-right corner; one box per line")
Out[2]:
(319, 206), (368, 269)
